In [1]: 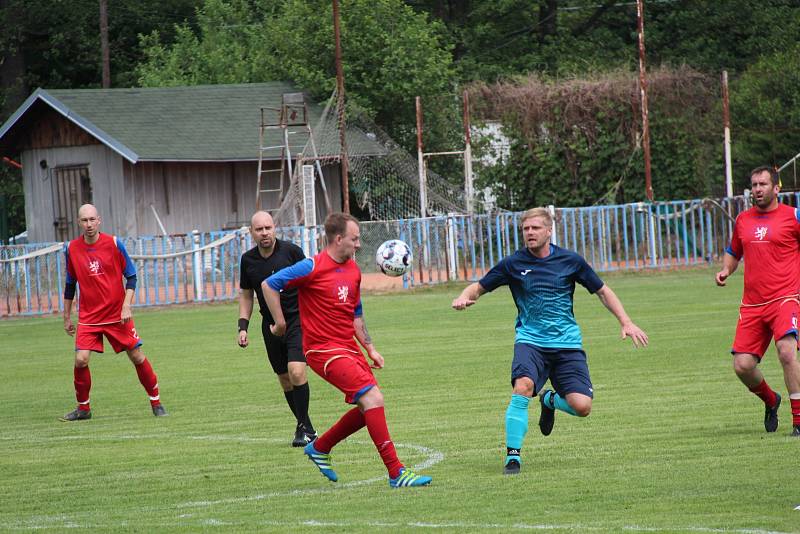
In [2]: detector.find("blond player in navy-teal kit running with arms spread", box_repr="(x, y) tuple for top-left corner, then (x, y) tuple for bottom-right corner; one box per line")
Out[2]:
(452, 208), (648, 474)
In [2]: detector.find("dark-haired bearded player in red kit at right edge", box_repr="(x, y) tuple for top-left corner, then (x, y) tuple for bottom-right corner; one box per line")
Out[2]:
(716, 167), (800, 437)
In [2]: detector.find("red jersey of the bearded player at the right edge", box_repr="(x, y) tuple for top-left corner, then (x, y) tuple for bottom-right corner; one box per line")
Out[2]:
(726, 204), (800, 306)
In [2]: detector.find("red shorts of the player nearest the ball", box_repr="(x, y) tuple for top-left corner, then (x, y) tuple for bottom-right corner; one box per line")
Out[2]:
(306, 352), (378, 404)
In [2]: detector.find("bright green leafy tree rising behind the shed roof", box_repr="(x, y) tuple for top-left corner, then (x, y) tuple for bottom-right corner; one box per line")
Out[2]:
(138, 0), (457, 153)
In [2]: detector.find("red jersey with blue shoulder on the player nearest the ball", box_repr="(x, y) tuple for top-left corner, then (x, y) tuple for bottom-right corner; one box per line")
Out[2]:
(267, 250), (361, 355)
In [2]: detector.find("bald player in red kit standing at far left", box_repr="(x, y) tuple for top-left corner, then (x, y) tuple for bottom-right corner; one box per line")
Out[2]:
(61, 204), (167, 421)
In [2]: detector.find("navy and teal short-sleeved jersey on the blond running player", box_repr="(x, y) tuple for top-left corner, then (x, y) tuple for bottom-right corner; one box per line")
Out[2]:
(478, 245), (603, 349)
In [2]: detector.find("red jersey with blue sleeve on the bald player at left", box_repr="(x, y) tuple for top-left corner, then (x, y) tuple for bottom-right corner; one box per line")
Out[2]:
(64, 233), (136, 325)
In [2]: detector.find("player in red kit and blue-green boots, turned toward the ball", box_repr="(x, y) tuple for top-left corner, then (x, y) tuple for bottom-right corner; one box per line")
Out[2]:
(261, 213), (431, 488)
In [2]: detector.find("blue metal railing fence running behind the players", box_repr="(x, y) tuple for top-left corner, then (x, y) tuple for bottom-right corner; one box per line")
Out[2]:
(0, 197), (776, 317)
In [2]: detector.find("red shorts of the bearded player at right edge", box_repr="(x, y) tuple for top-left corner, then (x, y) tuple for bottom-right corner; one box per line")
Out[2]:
(731, 298), (800, 359)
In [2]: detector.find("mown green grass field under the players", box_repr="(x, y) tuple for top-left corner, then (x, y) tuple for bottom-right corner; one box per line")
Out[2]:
(0, 270), (800, 533)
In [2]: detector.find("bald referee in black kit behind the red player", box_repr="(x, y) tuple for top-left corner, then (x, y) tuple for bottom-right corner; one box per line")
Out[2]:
(238, 211), (317, 447)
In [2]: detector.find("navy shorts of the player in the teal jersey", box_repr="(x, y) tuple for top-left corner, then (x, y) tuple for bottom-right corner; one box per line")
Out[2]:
(511, 343), (594, 397)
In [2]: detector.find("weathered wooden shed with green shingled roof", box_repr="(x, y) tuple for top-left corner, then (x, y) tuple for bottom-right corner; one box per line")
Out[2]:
(0, 82), (350, 242)
